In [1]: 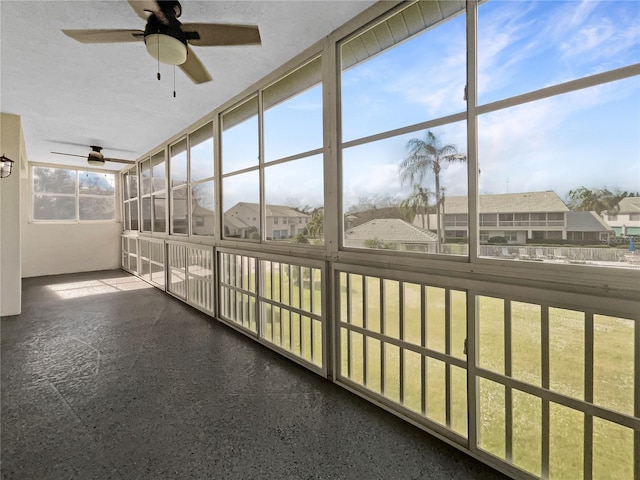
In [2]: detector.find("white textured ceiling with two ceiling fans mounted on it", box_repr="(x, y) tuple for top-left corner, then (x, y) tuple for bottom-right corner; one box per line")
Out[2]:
(0, 0), (375, 170)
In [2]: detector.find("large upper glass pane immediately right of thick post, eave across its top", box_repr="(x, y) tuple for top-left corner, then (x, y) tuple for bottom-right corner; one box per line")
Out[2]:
(341, 2), (466, 141)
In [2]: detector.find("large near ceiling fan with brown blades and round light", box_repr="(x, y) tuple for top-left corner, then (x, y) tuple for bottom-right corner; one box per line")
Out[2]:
(62, 0), (260, 83)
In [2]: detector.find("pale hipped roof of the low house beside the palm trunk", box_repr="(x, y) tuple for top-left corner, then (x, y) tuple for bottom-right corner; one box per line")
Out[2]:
(346, 218), (437, 243)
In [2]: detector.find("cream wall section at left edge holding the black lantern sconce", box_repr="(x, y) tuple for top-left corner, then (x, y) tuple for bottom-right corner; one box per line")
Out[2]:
(0, 113), (26, 316)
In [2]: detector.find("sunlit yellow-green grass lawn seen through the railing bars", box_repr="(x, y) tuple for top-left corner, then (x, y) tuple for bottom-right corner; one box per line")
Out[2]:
(220, 261), (634, 480)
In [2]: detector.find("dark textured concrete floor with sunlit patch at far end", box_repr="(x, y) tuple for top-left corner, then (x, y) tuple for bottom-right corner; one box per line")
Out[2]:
(1, 271), (504, 480)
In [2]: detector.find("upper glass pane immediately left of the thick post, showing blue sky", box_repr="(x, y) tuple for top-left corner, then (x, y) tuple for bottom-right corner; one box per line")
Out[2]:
(262, 58), (322, 161)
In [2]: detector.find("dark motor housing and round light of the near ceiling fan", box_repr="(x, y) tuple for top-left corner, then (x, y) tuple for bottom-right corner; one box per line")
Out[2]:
(144, 2), (187, 65)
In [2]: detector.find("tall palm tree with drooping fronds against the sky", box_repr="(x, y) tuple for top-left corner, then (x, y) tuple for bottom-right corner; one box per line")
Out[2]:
(399, 130), (467, 251)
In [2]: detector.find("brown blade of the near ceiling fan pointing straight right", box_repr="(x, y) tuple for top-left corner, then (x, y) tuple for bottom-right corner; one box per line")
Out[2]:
(182, 23), (260, 47)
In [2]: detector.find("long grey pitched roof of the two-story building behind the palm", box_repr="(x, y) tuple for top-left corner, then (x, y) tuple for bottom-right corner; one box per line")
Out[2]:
(444, 191), (569, 214)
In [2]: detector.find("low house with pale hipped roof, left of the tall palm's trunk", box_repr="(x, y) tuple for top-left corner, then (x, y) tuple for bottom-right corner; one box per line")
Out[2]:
(344, 218), (437, 252)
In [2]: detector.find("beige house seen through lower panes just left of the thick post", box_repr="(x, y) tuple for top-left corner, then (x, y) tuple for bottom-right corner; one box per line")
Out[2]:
(224, 202), (310, 240)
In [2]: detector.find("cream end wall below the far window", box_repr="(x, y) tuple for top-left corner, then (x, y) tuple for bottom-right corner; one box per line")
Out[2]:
(22, 181), (122, 278)
